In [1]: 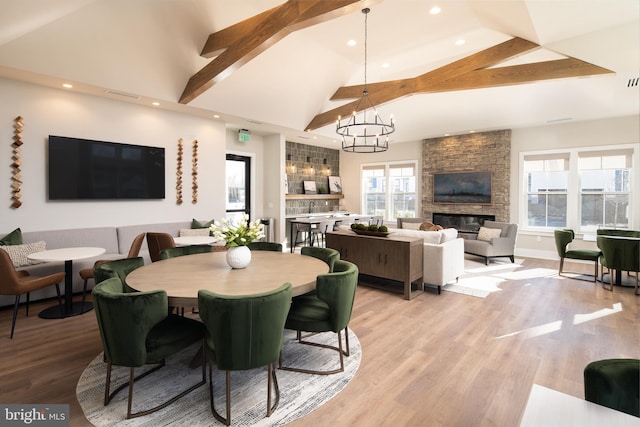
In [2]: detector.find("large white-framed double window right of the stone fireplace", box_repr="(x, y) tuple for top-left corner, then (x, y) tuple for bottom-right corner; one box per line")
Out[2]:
(520, 146), (638, 232)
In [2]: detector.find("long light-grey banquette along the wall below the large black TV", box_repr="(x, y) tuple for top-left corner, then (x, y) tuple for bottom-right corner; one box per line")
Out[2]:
(0, 221), (191, 307)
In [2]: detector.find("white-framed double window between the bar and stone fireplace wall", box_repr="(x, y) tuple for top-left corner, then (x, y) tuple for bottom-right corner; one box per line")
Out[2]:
(361, 162), (417, 219)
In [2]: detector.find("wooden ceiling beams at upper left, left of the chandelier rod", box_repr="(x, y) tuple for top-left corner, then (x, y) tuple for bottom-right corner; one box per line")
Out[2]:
(179, 0), (360, 104)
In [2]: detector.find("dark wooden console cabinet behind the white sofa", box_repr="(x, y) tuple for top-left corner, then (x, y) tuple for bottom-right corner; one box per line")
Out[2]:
(326, 230), (424, 300)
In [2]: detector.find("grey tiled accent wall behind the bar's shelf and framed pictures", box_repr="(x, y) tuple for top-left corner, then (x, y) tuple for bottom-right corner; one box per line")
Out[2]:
(285, 141), (340, 214)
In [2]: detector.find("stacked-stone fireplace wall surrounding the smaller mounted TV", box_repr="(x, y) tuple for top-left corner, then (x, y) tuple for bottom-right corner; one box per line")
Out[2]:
(422, 129), (511, 222)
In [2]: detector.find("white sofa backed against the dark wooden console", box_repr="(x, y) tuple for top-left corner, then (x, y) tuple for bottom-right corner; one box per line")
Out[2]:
(389, 219), (464, 294)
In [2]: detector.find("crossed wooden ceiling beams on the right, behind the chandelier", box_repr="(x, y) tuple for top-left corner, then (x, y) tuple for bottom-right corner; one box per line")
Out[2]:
(306, 37), (612, 131)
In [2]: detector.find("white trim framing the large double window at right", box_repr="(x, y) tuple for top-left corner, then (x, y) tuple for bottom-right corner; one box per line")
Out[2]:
(518, 143), (640, 234)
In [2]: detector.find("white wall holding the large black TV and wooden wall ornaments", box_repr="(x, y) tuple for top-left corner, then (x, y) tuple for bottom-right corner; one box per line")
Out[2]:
(0, 79), (226, 235)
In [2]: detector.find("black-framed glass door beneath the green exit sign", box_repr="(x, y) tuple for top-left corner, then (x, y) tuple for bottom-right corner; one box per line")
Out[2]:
(226, 154), (251, 221)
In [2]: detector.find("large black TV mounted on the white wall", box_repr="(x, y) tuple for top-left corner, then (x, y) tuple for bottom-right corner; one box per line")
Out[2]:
(49, 135), (165, 200)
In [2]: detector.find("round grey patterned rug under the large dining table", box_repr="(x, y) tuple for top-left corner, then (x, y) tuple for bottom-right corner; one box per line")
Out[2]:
(76, 330), (362, 427)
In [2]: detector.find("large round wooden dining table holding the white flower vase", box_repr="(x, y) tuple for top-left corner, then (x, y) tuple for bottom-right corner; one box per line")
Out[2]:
(126, 251), (329, 307)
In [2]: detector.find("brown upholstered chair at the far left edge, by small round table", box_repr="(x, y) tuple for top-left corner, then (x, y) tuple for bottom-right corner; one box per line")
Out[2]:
(0, 249), (65, 338)
